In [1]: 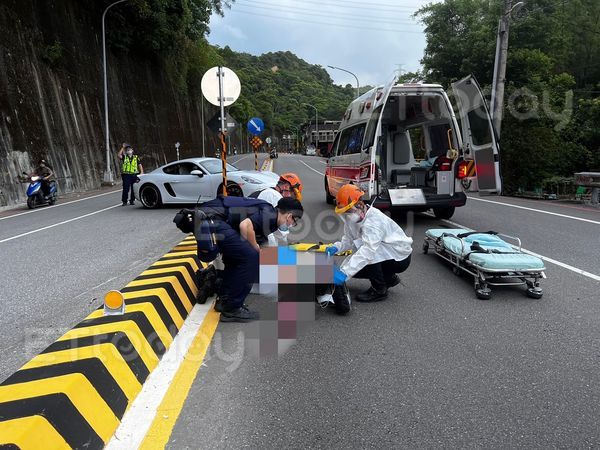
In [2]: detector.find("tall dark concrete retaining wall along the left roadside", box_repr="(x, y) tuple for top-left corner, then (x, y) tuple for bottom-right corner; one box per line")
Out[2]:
(0, 0), (215, 207)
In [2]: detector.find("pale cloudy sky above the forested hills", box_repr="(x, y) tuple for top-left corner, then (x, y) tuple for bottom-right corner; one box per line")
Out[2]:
(208, 0), (431, 86)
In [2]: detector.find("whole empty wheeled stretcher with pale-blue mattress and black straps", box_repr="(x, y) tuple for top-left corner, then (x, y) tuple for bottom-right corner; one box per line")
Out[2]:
(423, 228), (546, 300)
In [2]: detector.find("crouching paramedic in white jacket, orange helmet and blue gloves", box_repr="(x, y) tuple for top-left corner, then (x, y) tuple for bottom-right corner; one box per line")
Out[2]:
(326, 184), (412, 302)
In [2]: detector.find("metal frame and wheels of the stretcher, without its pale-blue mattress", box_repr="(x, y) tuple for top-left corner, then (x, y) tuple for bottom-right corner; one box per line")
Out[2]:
(423, 233), (546, 300)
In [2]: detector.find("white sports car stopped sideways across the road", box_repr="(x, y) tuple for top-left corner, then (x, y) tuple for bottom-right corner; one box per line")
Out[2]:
(133, 158), (279, 208)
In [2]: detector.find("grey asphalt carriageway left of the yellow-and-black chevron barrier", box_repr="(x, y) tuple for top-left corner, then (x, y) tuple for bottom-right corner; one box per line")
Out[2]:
(0, 156), (264, 380)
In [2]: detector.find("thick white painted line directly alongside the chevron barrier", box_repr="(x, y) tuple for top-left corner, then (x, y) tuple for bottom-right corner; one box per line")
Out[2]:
(105, 302), (212, 450)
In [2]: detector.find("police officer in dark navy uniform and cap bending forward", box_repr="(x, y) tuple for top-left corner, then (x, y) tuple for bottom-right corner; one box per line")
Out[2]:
(196, 196), (304, 322)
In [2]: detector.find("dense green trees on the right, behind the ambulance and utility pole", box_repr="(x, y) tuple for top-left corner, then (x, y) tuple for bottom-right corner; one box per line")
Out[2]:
(416, 0), (600, 193)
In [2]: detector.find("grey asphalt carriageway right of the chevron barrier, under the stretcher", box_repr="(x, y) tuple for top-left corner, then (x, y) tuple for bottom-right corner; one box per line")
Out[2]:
(169, 155), (600, 449)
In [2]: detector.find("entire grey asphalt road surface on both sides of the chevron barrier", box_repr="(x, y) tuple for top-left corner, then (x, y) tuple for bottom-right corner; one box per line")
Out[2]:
(0, 155), (600, 449)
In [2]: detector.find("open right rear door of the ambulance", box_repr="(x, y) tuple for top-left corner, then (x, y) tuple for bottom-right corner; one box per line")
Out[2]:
(452, 75), (502, 194)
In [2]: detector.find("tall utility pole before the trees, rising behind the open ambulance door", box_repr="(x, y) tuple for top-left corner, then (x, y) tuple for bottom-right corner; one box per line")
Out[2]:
(490, 0), (525, 139)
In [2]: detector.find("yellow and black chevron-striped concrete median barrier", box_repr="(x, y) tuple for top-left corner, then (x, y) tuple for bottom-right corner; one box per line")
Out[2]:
(0, 237), (203, 450)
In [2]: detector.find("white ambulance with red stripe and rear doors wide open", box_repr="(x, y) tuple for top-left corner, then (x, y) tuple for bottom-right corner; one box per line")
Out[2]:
(325, 76), (502, 219)
